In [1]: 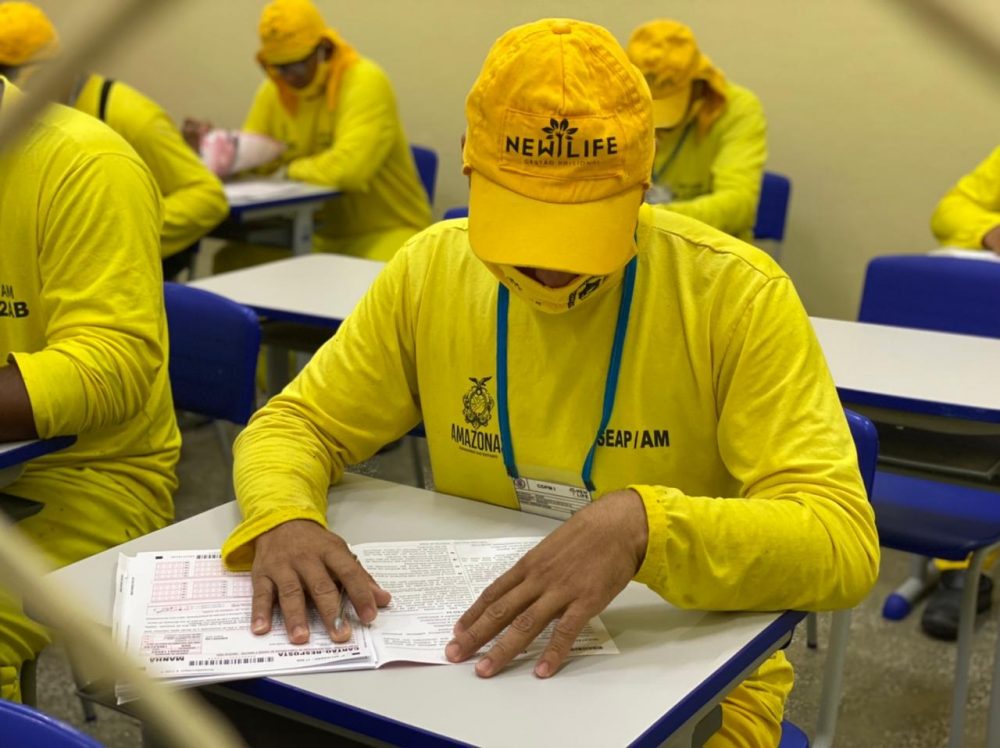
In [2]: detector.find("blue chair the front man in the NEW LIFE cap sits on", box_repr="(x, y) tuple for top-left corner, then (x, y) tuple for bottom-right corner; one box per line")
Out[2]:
(778, 408), (878, 748)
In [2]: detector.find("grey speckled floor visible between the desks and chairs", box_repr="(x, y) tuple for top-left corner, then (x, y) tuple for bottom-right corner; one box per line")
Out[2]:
(29, 418), (997, 748)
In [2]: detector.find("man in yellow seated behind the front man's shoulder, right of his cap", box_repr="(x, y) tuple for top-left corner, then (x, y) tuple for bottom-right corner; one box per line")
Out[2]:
(627, 19), (767, 241)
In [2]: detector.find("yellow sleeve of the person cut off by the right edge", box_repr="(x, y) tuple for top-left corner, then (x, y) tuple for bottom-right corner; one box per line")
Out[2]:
(931, 148), (1000, 249)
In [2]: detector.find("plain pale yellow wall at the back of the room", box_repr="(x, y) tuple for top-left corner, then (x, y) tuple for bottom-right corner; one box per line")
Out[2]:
(37, 0), (1000, 318)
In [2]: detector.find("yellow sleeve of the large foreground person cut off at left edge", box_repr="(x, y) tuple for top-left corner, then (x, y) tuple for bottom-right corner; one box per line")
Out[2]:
(13, 154), (167, 437)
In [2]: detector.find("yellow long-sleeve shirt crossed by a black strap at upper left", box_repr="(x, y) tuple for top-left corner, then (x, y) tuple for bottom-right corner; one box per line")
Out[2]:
(73, 75), (229, 257)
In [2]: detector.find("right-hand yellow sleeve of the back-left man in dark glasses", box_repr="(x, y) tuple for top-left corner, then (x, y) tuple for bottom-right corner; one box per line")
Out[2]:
(288, 61), (398, 192)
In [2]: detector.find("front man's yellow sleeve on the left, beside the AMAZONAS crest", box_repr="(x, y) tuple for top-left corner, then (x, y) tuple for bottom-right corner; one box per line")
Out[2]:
(222, 247), (420, 569)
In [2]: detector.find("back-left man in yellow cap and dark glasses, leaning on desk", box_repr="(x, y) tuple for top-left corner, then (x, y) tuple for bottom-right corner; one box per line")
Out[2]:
(185, 0), (432, 272)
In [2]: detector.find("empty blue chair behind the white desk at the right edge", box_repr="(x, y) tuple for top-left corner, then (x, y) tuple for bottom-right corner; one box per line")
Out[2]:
(858, 255), (1000, 747)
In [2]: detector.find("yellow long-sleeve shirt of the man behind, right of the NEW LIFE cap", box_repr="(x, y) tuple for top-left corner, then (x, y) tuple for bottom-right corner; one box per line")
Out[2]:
(653, 83), (767, 241)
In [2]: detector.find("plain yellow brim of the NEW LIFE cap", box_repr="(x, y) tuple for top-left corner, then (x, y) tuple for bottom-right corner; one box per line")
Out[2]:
(469, 171), (644, 275)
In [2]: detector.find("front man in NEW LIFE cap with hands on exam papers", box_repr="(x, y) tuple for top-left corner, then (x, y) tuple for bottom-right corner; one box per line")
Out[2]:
(223, 19), (879, 746)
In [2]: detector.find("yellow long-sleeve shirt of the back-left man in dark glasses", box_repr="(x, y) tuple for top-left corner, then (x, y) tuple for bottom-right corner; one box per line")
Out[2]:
(243, 58), (432, 254)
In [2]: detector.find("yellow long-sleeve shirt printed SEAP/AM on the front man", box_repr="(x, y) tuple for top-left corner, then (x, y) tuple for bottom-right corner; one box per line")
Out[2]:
(223, 206), (879, 739)
